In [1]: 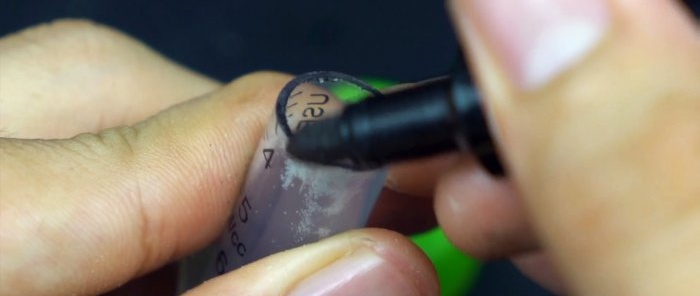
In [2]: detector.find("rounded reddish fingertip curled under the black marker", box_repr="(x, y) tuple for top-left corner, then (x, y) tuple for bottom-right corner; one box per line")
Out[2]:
(435, 157), (538, 259)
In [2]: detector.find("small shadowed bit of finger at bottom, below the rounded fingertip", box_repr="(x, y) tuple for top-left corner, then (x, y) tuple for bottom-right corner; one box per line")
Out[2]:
(513, 251), (566, 295)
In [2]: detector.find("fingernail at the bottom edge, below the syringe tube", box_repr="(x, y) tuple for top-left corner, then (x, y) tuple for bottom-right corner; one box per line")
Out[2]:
(289, 250), (421, 296)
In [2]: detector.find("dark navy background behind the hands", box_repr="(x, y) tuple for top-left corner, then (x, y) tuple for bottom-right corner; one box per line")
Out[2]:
(0, 0), (700, 295)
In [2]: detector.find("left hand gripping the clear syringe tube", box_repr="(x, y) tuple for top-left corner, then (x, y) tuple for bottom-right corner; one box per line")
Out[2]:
(0, 21), (437, 295)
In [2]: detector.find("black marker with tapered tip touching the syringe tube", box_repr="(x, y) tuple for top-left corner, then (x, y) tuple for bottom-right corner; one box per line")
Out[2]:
(287, 64), (504, 175)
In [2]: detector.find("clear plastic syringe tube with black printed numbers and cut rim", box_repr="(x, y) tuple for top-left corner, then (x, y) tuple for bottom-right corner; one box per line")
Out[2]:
(180, 72), (386, 288)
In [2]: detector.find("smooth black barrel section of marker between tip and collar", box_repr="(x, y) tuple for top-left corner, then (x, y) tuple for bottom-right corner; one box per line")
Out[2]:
(342, 77), (458, 167)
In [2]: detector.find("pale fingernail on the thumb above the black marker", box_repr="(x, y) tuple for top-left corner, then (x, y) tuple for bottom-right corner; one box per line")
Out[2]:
(452, 0), (609, 90)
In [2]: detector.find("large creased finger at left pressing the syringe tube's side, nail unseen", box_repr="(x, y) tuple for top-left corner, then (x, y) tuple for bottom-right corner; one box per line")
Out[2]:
(0, 73), (289, 295)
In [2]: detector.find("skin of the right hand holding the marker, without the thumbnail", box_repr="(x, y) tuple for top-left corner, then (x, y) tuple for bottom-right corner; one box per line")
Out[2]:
(396, 0), (700, 295)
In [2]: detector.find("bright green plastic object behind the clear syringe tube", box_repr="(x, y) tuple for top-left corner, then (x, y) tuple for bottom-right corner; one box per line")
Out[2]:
(333, 78), (481, 296)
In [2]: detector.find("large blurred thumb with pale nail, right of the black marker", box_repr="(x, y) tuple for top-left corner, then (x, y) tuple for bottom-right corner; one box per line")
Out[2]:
(451, 0), (700, 295)
